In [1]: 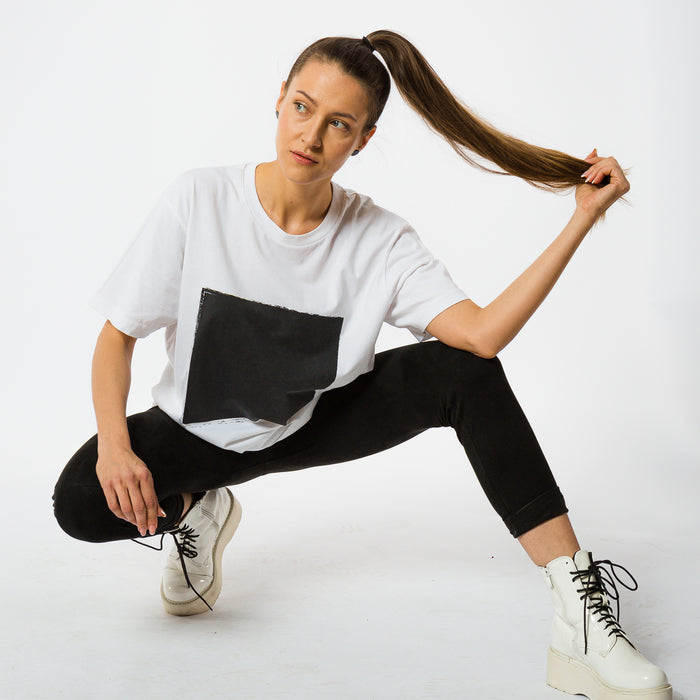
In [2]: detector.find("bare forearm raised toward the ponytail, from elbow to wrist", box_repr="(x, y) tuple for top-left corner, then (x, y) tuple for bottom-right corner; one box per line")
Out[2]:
(479, 209), (594, 355)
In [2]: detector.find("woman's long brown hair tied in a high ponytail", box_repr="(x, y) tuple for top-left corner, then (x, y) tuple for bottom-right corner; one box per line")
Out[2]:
(287, 29), (626, 208)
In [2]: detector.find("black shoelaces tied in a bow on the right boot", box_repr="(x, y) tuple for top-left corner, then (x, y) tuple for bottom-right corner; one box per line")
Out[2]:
(569, 555), (639, 654)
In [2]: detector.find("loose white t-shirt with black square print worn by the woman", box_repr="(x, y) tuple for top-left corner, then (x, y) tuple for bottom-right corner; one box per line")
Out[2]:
(89, 163), (468, 452)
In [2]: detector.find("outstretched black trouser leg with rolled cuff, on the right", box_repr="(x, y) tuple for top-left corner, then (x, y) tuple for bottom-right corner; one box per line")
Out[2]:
(258, 340), (566, 536)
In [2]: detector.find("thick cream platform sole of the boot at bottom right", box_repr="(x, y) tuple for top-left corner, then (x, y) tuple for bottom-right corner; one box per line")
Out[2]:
(547, 647), (672, 700)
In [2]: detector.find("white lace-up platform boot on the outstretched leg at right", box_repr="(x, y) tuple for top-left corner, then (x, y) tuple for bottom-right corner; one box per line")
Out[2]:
(538, 550), (672, 700)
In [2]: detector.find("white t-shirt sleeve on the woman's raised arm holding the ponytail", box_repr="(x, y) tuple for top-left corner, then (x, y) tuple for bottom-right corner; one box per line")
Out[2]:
(384, 224), (469, 341)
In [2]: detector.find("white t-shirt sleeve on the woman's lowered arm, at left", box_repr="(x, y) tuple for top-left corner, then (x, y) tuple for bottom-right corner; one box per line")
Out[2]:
(88, 175), (187, 338)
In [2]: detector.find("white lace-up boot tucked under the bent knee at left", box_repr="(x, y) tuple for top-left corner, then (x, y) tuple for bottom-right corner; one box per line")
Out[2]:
(160, 488), (242, 615)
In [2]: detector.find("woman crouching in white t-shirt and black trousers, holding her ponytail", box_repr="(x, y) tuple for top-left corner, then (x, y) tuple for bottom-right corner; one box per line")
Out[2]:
(54, 31), (671, 698)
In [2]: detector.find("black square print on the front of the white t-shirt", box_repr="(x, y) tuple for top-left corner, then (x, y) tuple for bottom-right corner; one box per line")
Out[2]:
(182, 287), (343, 425)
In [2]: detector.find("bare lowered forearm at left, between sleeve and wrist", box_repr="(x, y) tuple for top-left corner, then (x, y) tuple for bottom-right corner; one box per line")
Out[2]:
(92, 327), (133, 449)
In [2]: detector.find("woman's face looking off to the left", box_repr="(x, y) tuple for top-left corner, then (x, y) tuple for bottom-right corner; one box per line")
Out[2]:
(276, 60), (376, 184)
